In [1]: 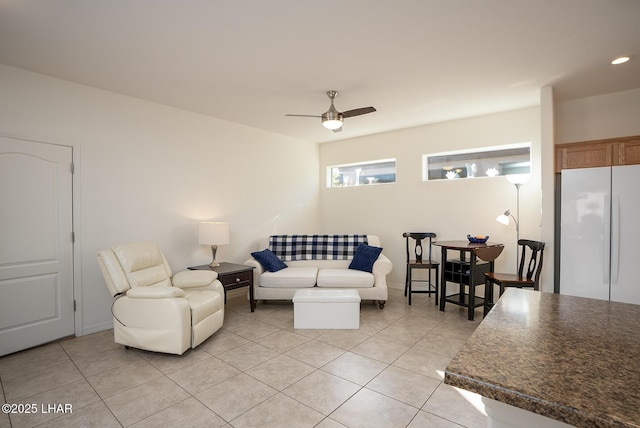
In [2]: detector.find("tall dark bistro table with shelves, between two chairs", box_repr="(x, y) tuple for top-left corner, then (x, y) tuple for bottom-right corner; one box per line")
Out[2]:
(433, 241), (504, 321)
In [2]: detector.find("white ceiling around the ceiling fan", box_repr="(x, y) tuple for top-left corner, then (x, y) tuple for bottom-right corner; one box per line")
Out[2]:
(0, 0), (640, 142)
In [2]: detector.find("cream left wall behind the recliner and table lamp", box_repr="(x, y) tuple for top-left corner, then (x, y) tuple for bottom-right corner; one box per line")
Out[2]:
(0, 65), (319, 334)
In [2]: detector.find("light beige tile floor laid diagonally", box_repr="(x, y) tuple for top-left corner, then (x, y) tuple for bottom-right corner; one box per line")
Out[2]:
(0, 289), (487, 428)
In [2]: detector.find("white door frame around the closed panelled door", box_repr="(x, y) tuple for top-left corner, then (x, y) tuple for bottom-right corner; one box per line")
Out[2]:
(0, 132), (85, 336)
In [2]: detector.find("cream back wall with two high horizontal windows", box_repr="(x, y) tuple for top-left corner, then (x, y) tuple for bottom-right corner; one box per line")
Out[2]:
(320, 107), (540, 287)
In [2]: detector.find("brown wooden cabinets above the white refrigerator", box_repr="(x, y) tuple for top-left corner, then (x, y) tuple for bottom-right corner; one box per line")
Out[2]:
(556, 135), (640, 172)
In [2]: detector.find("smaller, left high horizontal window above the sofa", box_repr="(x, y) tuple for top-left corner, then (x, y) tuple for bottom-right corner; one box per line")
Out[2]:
(327, 159), (396, 187)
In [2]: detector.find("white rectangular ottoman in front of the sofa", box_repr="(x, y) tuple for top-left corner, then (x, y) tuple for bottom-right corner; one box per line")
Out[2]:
(293, 288), (360, 329)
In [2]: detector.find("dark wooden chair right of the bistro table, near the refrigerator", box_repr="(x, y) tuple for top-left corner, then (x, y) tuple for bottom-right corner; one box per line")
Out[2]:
(484, 239), (544, 315)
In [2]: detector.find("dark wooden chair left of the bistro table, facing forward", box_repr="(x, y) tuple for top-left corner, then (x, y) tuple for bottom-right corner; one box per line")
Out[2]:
(402, 232), (440, 305)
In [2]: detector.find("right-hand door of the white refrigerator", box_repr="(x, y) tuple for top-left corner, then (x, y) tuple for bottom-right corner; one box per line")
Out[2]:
(611, 165), (640, 304)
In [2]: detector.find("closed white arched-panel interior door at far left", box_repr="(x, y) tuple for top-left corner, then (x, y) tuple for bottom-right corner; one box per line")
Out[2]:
(0, 137), (74, 356)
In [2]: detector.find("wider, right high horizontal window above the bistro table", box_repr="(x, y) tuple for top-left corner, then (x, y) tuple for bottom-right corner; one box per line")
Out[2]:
(422, 143), (531, 181)
